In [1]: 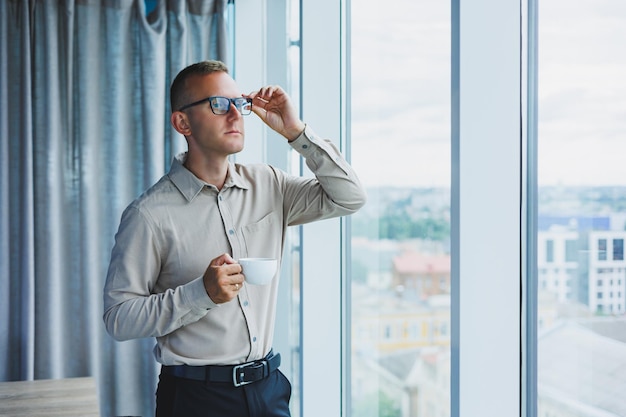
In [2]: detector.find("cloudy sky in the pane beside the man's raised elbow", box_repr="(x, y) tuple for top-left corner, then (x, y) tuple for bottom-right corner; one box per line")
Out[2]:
(351, 0), (450, 186)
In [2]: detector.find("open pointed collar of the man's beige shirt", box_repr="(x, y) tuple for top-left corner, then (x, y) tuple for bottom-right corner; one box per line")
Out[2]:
(167, 152), (250, 201)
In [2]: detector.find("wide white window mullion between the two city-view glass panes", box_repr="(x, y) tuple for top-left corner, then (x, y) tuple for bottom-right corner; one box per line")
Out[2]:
(452, 0), (523, 417)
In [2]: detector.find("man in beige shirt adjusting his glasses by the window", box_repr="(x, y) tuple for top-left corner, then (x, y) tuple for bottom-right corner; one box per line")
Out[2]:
(104, 61), (365, 417)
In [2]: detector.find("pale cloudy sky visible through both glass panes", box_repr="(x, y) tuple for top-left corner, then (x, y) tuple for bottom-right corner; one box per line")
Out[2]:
(351, 0), (626, 187)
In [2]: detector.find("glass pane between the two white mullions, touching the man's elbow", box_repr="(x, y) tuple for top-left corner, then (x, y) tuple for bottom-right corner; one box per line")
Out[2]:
(349, 0), (451, 417)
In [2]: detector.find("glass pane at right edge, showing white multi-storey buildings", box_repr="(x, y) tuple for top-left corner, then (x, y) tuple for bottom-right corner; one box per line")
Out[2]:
(537, 0), (626, 417)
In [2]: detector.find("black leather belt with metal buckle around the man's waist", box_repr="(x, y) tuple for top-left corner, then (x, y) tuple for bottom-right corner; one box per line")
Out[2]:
(161, 351), (280, 387)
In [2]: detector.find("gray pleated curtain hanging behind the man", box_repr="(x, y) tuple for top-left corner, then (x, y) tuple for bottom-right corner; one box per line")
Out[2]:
(0, 0), (229, 416)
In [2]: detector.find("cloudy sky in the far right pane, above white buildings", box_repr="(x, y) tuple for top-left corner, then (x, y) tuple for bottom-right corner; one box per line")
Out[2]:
(538, 0), (626, 185)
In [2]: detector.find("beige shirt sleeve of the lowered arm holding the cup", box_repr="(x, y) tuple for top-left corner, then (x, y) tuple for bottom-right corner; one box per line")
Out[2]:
(104, 202), (216, 340)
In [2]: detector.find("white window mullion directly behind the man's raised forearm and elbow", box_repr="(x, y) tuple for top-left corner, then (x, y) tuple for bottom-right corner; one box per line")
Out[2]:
(301, 0), (343, 416)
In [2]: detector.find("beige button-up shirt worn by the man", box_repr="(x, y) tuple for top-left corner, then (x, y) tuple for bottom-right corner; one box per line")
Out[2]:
(104, 127), (365, 365)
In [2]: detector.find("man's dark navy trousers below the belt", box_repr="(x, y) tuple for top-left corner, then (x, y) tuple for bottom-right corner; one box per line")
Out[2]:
(156, 370), (291, 417)
